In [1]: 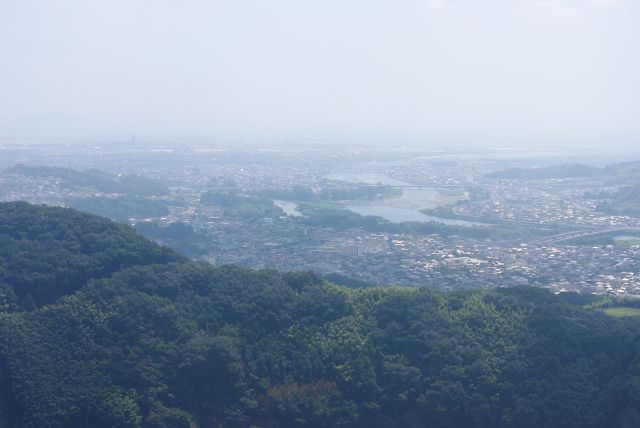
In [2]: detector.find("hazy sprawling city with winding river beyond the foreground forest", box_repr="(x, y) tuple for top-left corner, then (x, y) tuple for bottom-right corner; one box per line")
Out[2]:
(0, 144), (640, 296)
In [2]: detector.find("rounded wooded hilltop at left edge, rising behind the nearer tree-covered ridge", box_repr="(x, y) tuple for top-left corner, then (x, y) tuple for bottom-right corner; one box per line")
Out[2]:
(0, 202), (182, 309)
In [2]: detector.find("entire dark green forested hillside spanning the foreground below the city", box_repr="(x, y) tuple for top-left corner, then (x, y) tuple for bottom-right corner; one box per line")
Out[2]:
(0, 204), (640, 428)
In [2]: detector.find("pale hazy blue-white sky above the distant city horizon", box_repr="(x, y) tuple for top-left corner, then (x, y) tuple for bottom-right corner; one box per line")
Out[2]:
(0, 0), (640, 147)
